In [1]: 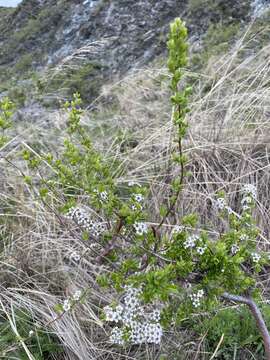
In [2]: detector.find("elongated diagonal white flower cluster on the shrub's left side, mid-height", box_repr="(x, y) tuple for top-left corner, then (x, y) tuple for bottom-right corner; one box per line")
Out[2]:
(66, 207), (107, 237)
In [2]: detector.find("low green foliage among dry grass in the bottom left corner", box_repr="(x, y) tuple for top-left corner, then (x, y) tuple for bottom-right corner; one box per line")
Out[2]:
(0, 310), (62, 360)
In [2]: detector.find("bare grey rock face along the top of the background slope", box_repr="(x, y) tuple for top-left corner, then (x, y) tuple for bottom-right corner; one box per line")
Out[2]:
(0, 0), (255, 73)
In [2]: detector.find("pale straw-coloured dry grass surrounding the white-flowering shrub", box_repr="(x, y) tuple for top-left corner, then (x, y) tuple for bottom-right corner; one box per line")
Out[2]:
(0, 21), (270, 360)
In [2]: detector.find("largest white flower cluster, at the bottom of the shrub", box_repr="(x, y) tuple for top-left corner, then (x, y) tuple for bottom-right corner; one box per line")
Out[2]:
(104, 287), (162, 345)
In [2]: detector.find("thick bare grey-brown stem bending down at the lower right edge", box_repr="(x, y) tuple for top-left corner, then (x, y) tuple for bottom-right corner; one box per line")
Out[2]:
(222, 292), (270, 360)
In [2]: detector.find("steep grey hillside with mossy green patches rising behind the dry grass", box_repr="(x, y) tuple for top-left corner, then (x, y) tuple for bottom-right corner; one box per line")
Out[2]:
(0, 0), (260, 102)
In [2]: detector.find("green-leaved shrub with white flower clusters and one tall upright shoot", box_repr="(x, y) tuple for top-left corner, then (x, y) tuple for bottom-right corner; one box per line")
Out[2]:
(20, 19), (270, 359)
